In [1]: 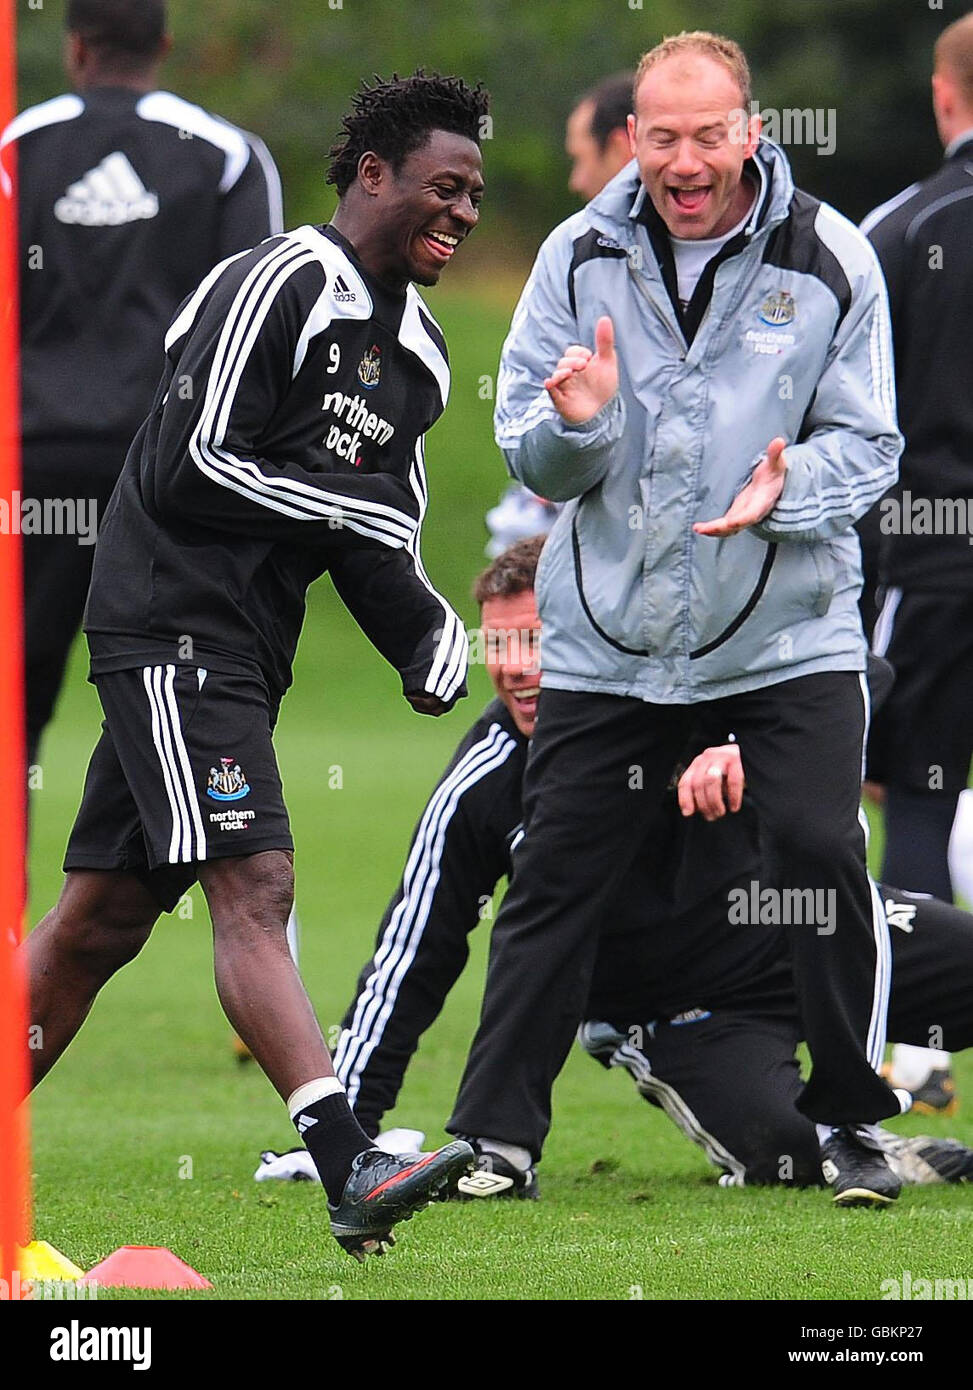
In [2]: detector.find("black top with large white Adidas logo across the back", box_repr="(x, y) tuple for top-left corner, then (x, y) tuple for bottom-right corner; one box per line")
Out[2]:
(3, 86), (284, 450)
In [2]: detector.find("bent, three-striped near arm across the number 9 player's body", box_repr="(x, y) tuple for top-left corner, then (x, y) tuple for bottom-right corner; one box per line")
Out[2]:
(152, 252), (420, 549)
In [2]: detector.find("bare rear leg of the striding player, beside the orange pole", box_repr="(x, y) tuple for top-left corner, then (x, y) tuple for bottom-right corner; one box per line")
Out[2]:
(21, 869), (161, 1086)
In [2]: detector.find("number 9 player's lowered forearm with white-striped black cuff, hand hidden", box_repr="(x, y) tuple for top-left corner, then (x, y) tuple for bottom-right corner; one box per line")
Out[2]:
(331, 549), (468, 714)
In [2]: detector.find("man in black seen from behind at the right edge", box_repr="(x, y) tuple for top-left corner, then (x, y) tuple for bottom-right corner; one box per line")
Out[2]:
(862, 14), (973, 899)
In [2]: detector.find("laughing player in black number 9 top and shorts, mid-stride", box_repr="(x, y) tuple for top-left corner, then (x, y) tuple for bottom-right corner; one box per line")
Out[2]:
(26, 74), (487, 1257)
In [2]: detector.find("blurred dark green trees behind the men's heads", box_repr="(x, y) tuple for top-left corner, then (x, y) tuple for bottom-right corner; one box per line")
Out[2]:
(18, 0), (967, 277)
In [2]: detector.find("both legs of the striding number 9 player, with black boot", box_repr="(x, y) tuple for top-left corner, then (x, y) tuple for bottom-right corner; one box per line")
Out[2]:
(24, 851), (473, 1259)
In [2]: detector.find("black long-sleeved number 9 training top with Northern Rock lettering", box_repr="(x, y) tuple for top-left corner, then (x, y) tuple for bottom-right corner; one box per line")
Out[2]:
(85, 227), (467, 705)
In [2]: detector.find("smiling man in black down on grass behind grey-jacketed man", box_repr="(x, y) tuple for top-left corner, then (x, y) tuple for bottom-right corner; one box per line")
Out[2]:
(319, 537), (973, 1195)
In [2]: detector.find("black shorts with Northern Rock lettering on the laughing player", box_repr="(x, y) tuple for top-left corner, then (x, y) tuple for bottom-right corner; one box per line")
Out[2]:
(64, 666), (293, 912)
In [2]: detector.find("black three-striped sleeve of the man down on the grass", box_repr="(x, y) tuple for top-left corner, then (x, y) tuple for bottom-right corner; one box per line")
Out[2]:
(335, 724), (521, 1130)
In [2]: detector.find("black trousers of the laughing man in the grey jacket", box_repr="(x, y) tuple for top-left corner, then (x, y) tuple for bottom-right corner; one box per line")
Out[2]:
(446, 671), (899, 1159)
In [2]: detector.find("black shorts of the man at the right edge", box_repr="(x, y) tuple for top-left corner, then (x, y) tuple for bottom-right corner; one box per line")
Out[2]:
(867, 589), (973, 795)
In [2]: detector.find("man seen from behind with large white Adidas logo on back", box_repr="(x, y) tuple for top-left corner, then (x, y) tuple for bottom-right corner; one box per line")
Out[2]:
(1, 0), (284, 763)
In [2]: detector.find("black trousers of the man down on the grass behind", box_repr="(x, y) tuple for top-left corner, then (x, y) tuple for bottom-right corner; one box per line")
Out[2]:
(588, 887), (973, 1186)
